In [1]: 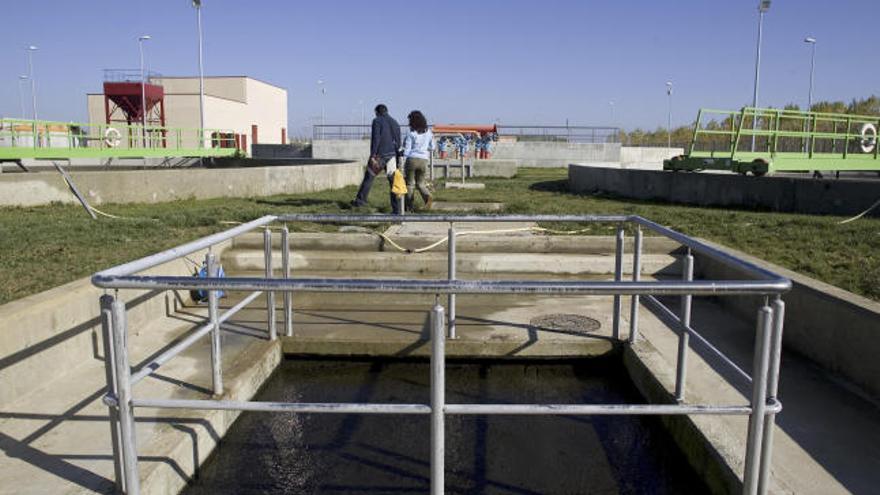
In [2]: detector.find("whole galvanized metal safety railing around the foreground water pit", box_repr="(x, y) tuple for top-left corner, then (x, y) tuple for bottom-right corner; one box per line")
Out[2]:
(92, 214), (791, 494)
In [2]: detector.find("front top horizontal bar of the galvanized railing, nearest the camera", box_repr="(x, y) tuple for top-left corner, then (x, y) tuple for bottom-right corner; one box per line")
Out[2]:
(92, 274), (789, 296)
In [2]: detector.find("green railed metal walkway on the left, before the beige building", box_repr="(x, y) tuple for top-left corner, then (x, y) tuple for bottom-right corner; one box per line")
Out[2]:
(0, 119), (238, 161)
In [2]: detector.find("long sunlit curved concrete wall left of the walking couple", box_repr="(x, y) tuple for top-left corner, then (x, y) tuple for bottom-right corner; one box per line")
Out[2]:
(0, 162), (364, 206)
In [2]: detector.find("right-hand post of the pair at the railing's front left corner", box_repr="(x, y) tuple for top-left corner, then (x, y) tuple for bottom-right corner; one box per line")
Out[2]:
(111, 299), (140, 495)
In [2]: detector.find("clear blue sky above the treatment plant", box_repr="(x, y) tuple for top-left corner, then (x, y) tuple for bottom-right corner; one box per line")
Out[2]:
(0, 0), (880, 135)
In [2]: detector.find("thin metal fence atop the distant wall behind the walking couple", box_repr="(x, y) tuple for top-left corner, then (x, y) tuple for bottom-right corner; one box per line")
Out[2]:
(312, 124), (620, 143)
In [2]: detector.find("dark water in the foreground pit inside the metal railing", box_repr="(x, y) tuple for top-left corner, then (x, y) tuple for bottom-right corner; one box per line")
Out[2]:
(185, 359), (706, 495)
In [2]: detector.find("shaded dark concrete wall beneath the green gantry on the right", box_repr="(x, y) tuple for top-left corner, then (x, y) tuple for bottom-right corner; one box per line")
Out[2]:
(568, 165), (880, 215)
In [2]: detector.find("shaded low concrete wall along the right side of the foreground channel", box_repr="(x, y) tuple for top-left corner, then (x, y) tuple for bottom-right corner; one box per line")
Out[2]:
(695, 245), (880, 398)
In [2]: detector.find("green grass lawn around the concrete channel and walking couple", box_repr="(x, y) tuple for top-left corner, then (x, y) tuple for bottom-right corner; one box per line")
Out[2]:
(0, 169), (880, 304)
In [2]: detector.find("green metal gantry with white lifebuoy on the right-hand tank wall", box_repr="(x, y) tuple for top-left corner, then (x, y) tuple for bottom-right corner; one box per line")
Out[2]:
(663, 107), (880, 176)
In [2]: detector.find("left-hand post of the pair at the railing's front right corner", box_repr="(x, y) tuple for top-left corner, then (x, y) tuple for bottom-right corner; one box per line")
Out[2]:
(743, 302), (773, 495)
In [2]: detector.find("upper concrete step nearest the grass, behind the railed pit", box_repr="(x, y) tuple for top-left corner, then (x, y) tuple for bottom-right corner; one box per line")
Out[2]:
(233, 233), (680, 254)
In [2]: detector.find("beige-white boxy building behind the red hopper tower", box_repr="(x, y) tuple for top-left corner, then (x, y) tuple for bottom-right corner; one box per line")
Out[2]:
(87, 76), (287, 153)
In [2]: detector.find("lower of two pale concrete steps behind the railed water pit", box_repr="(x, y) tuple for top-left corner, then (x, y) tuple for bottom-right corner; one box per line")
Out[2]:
(222, 248), (681, 278)
